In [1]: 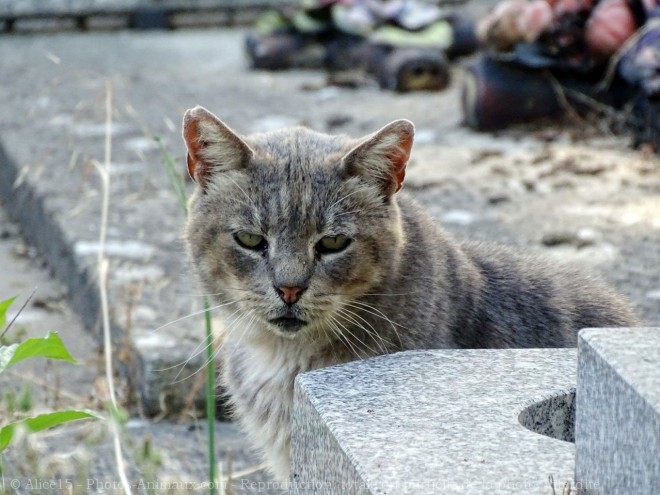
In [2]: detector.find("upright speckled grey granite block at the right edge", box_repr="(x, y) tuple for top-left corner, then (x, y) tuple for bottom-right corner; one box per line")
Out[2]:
(575, 328), (660, 495)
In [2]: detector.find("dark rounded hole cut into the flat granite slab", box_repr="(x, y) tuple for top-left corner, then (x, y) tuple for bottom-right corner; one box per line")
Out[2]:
(518, 389), (575, 443)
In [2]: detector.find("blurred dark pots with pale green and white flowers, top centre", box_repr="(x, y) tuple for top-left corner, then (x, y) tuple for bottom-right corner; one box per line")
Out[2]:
(246, 0), (477, 91)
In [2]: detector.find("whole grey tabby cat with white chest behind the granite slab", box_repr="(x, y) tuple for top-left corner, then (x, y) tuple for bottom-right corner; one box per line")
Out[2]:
(183, 107), (635, 479)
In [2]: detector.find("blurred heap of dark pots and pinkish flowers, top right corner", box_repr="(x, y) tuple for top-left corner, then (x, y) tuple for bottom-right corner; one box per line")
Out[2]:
(463, 0), (660, 152)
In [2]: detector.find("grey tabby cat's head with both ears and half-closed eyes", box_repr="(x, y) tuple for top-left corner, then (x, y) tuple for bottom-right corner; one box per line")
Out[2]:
(183, 107), (414, 339)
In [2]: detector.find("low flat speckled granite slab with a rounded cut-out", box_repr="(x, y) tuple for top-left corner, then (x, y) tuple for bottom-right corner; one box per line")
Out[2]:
(291, 349), (576, 495)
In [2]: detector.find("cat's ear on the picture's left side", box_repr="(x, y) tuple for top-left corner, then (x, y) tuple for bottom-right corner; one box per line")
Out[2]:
(183, 106), (253, 188)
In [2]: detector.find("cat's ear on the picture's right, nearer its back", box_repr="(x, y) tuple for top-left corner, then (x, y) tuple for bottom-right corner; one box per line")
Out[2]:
(342, 119), (415, 197)
